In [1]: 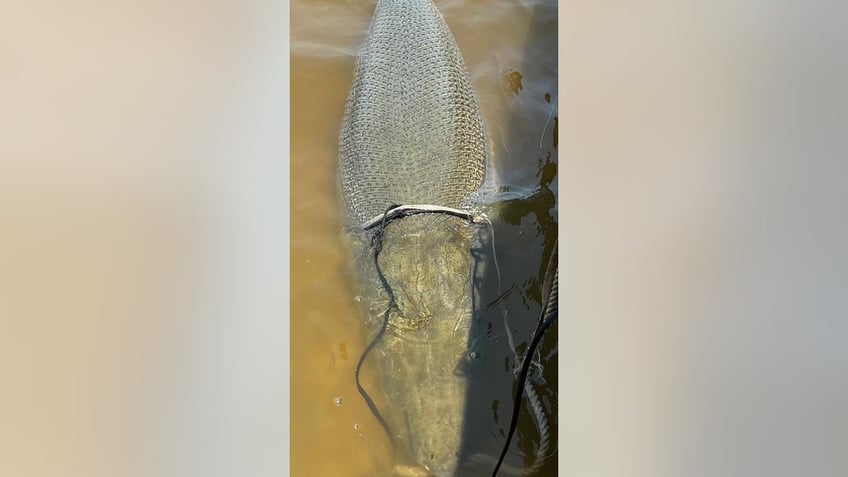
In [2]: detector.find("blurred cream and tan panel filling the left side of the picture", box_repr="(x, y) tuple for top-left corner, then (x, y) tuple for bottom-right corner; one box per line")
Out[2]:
(0, 0), (289, 477)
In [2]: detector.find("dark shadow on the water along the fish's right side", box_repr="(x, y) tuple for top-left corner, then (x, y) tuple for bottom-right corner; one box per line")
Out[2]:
(457, 1), (558, 477)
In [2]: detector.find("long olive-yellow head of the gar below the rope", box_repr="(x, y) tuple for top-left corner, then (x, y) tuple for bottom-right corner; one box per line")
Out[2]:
(352, 218), (484, 477)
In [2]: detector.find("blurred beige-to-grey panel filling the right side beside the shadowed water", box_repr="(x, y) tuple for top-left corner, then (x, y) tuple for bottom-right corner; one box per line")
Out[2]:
(559, 1), (848, 477)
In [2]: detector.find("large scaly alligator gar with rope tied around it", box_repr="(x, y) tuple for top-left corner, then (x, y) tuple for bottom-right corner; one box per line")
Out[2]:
(338, 0), (489, 477)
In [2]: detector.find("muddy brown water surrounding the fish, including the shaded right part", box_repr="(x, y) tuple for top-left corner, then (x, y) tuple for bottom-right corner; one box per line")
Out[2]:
(291, 0), (558, 477)
